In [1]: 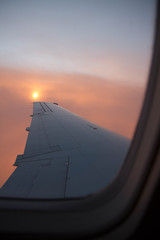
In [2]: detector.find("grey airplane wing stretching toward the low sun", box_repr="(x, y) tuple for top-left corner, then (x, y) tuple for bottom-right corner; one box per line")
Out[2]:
(0, 102), (130, 199)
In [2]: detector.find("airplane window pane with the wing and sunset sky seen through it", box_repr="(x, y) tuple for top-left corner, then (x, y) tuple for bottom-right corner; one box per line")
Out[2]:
(0, 0), (156, 198)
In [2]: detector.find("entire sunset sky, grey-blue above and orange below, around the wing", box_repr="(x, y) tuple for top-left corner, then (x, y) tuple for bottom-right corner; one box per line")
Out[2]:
(0, 0), (155, 186)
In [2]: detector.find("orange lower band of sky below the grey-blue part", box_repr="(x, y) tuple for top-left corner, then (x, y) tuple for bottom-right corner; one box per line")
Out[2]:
(0, 68), (144, 186)
